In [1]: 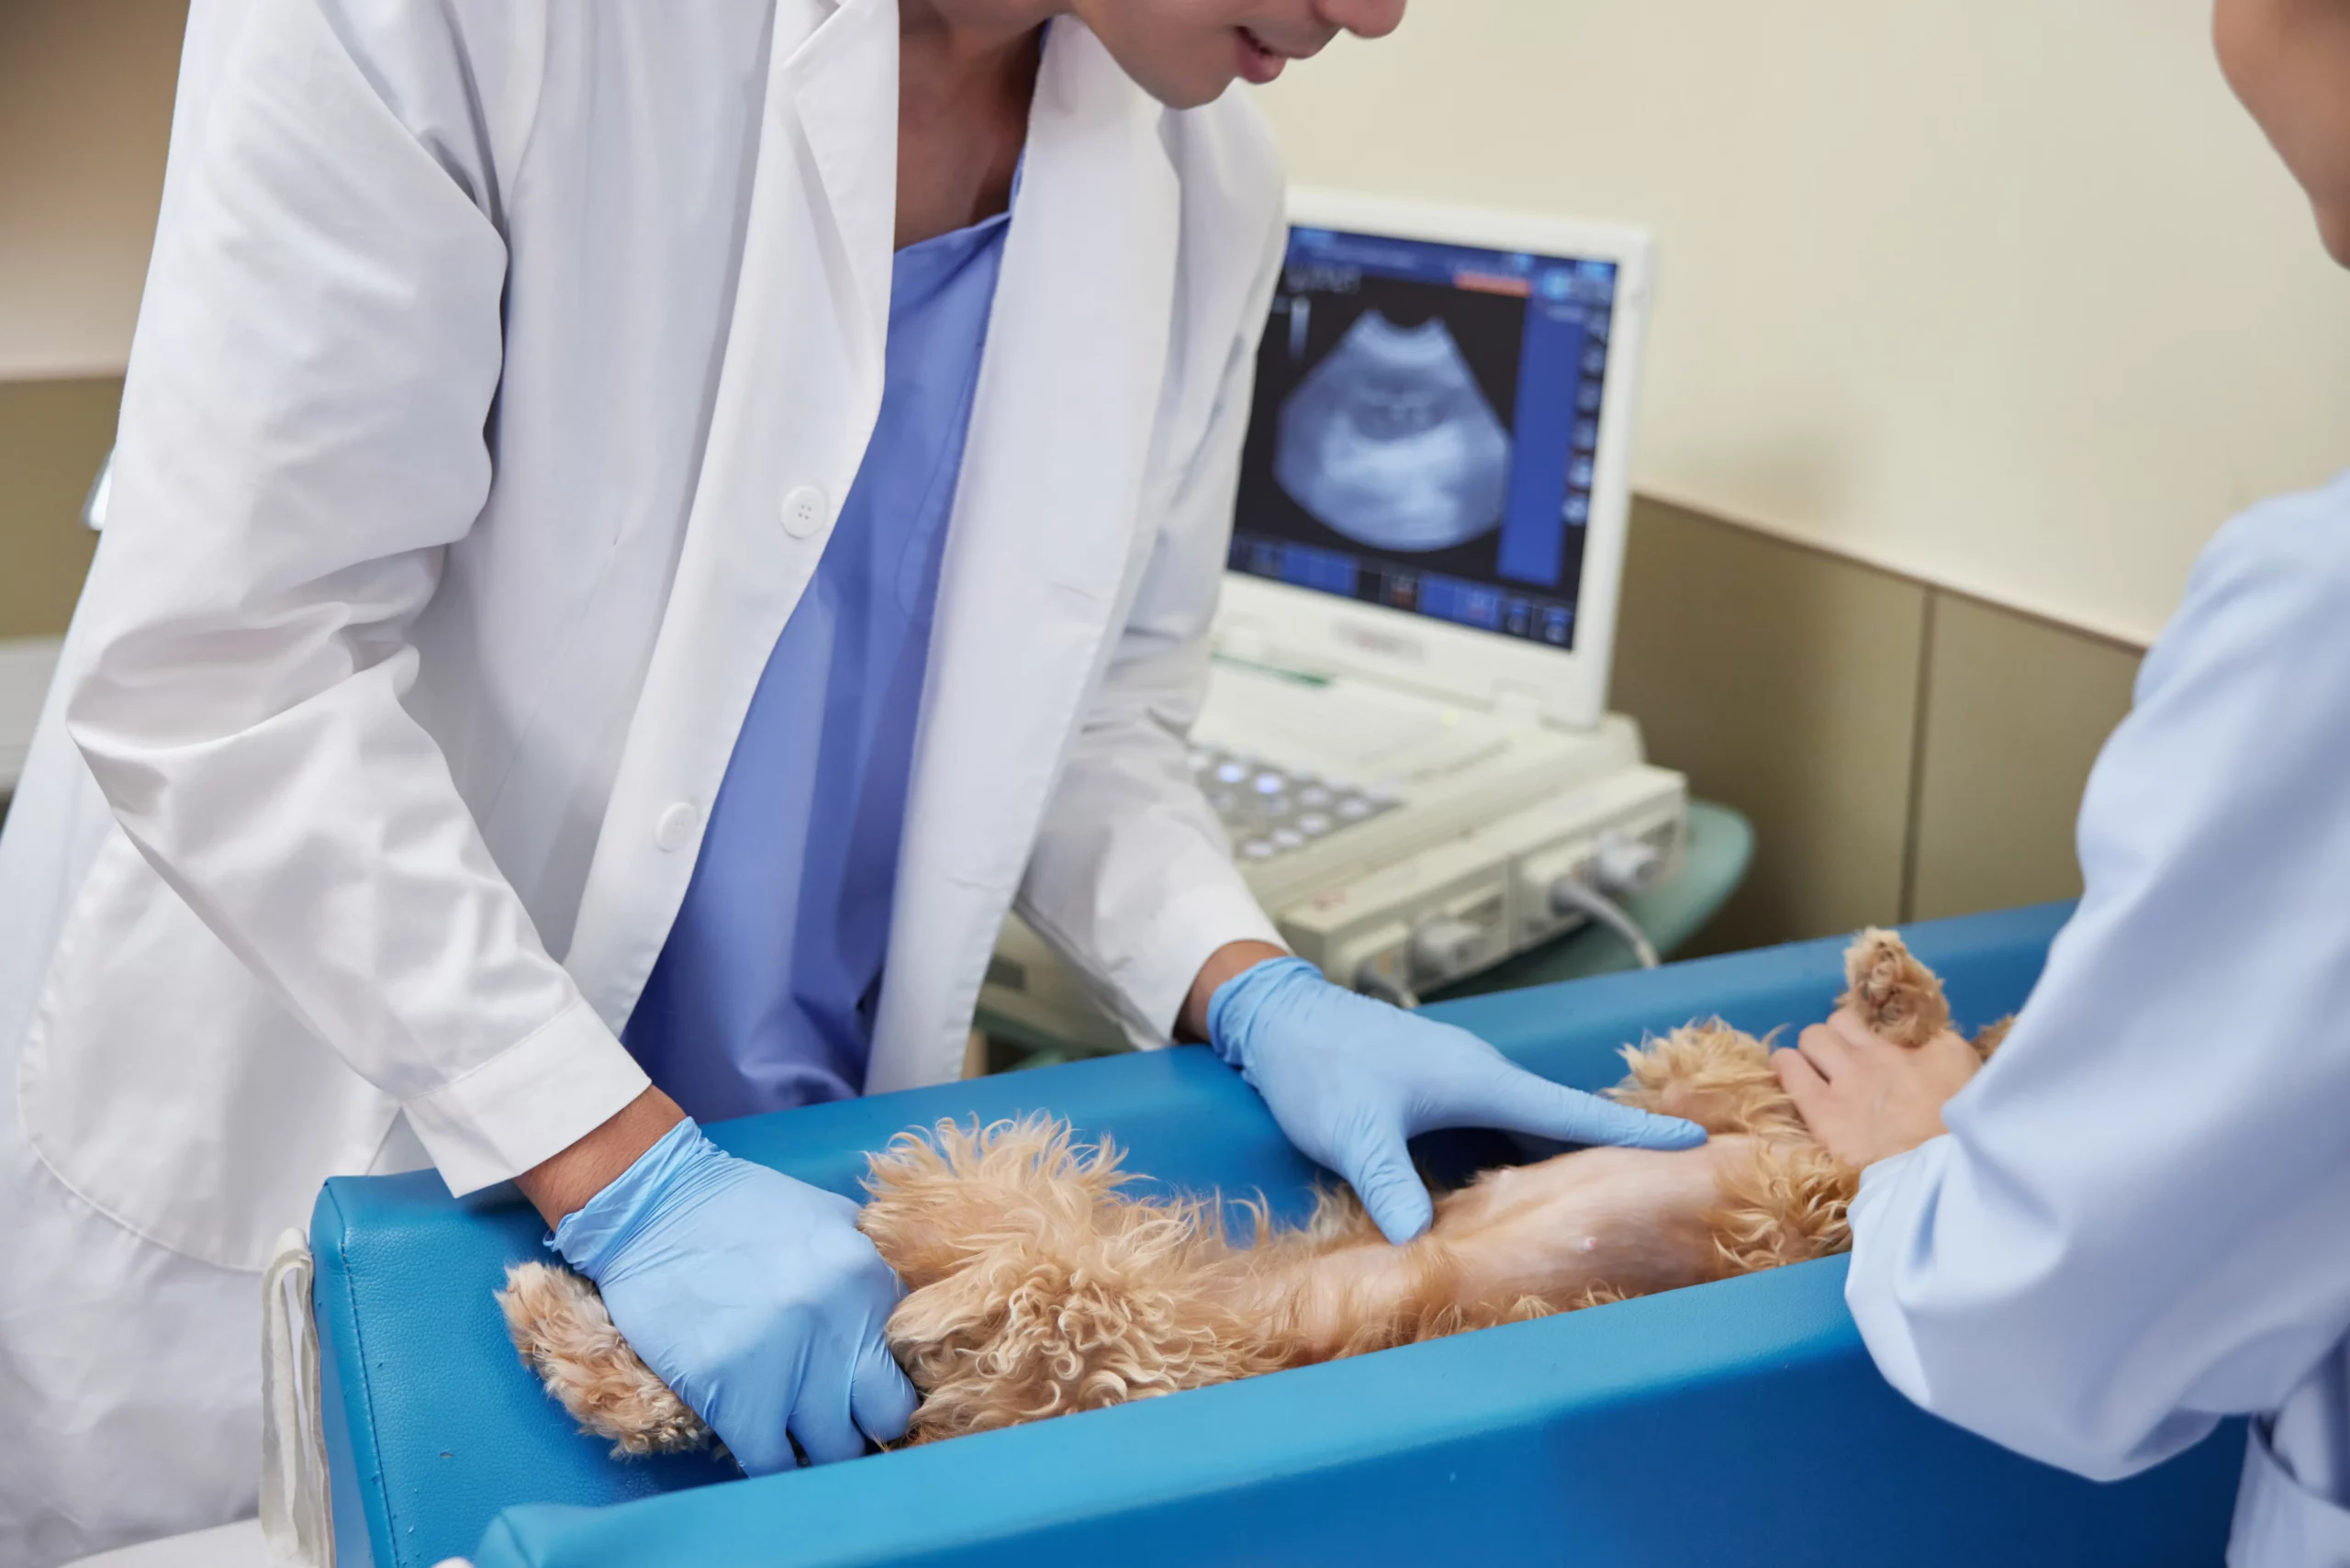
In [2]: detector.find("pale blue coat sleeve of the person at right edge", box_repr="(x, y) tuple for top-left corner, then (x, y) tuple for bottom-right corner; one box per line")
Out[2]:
(1847, 482), (2350, 1479)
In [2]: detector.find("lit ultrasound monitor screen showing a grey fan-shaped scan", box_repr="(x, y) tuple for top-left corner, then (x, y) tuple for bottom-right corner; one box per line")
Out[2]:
(1231, 228), (1617, 646)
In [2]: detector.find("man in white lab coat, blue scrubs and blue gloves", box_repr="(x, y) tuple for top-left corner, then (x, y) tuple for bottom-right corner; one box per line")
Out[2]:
(0, 0), (1690, 1568)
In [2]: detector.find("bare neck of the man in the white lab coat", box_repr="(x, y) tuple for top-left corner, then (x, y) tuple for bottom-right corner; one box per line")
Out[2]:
(898, 0), (1067, 249)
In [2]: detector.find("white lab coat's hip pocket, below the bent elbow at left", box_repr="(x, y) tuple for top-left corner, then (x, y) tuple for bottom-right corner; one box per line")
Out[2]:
(17, 827), (397, 1270)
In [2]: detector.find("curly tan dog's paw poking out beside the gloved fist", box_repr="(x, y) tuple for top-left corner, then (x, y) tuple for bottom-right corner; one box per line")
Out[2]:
(496, 1262), (712, 1458)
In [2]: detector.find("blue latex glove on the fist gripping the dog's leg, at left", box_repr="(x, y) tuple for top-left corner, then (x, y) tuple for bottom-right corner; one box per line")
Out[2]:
(547, 1119), (916, 1476)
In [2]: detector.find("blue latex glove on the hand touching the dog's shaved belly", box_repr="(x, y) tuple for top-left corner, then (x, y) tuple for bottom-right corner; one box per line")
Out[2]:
(1208, 959), (1707, 1244)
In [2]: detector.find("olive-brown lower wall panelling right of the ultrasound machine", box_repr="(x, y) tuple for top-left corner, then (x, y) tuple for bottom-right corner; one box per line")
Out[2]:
(1615, 500), (2139, 952)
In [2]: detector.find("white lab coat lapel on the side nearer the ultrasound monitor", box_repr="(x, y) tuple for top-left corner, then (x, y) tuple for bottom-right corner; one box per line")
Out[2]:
(865, 18), (1180, 1093)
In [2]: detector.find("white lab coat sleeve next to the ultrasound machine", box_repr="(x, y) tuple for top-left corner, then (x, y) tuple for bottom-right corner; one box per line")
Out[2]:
(1020, 202), (1288, 1047)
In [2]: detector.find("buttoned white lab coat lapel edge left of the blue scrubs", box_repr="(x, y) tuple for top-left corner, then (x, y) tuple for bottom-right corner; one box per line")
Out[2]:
(566, 0), (898, 1030)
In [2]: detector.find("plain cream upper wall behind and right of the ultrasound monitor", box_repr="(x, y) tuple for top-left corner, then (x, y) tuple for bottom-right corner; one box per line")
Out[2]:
(1264, 0), (2350, 642)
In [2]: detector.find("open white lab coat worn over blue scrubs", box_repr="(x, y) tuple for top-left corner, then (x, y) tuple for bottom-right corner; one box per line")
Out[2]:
(0, 0), (1283, 1556)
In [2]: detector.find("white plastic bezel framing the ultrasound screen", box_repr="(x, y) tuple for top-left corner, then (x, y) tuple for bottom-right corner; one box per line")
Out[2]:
(1217, 188), (1654, 729)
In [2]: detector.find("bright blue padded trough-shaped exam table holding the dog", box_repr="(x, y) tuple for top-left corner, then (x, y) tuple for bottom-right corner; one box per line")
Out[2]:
(310, 907), (2244, 1568)
